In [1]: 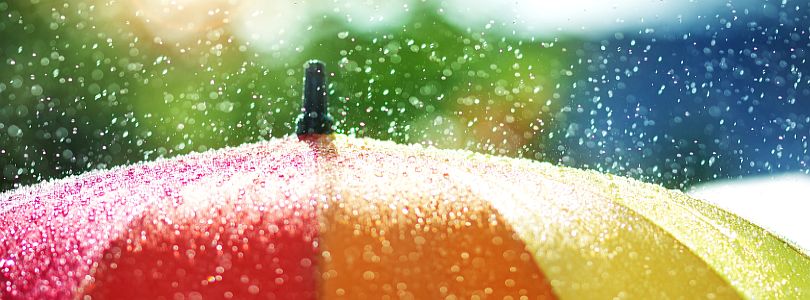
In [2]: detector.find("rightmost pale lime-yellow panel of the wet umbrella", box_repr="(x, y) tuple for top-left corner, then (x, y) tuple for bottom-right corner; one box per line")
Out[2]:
(589, 172), (810, 299)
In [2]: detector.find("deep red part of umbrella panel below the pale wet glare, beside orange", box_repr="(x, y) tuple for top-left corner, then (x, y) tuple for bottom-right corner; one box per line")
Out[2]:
(80, 200), (318, 299)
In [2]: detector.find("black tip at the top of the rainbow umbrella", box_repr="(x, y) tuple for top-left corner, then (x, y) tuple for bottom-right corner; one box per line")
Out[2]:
(296, 60), (334, 135)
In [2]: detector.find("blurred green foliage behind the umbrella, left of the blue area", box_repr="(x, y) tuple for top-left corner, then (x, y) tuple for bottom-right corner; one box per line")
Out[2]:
(0, 1), (571, 189)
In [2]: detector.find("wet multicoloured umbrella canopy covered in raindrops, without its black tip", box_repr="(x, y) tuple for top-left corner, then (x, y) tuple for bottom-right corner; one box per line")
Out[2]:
(0, 135), (810, 299)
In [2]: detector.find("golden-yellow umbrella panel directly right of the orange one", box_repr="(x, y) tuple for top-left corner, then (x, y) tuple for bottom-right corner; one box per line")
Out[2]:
(448, 157), (739, 299)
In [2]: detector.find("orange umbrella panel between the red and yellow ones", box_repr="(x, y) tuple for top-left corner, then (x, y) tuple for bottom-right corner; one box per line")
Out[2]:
(319, 141), (555, 299)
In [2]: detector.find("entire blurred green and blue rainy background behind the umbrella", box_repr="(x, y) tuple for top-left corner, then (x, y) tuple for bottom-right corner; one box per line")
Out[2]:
(0, 0), (810, 191)
